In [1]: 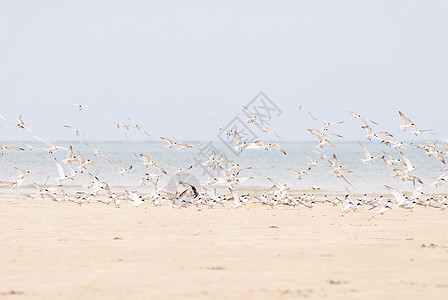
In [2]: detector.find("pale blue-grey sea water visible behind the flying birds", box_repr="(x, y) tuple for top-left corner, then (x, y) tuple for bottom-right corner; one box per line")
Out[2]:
(0, 141), (448, 194)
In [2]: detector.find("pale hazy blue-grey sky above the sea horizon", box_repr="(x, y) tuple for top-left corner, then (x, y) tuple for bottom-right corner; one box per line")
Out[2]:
(0, 0), (448, 140)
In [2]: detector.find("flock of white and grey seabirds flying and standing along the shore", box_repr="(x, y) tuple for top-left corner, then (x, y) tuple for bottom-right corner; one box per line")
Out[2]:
(0, 103), (448, 214)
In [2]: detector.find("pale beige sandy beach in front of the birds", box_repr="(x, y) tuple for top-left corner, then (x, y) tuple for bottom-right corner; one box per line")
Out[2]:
(0, 200), (448, 299)
